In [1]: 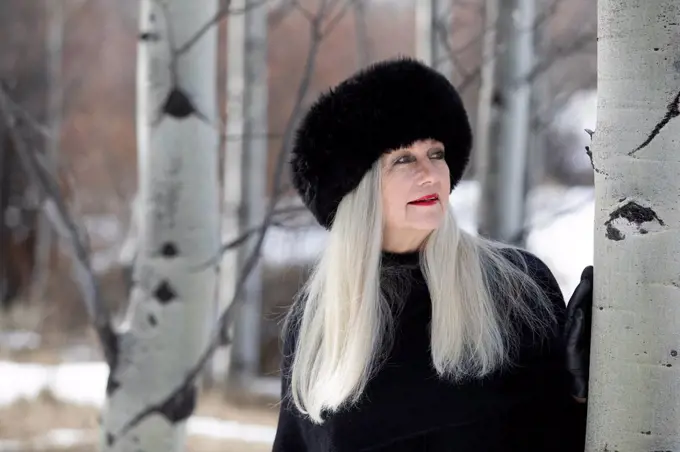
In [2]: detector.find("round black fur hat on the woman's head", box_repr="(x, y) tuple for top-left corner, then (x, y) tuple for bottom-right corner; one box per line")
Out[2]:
(290, 57), (472, 229)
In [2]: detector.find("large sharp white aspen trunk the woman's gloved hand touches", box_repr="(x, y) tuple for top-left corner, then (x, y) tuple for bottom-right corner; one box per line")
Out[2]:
(588, 0), (680, 452)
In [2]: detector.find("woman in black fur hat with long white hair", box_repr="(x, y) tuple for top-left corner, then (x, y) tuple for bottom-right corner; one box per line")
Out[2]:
(274, 58), (592, 452)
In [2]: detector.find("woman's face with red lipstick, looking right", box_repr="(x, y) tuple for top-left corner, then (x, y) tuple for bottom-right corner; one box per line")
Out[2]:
(381, 140), (451, 252)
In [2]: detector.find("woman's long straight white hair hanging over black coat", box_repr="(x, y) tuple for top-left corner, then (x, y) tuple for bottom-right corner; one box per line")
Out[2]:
(283, 160), (554, 424)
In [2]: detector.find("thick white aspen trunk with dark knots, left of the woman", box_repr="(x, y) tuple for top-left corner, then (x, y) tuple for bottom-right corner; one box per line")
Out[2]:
(102, 0), (219, 452)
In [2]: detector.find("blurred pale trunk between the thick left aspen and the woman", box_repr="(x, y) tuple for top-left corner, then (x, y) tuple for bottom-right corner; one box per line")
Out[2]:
(216, 0), (268, 388)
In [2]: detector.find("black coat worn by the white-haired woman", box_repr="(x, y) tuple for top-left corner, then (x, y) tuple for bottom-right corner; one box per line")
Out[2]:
(273, 249), (586, 452)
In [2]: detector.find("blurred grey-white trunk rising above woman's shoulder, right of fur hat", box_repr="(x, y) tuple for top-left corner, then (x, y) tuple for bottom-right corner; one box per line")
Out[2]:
(478, 0), (535, 244)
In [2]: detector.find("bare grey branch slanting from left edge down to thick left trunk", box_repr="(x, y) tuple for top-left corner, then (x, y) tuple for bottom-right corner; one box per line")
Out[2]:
(0, 86), (117, 366)
